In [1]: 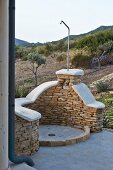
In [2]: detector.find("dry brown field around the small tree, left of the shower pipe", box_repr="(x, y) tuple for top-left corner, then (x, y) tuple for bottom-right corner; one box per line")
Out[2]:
(15, 56), (66, 84)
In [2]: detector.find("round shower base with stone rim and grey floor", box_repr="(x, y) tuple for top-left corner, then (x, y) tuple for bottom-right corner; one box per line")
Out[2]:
(39, 125), (90, 146)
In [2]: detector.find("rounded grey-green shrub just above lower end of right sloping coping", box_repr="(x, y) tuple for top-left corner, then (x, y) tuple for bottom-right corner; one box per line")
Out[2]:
(96, 81), (109, 93)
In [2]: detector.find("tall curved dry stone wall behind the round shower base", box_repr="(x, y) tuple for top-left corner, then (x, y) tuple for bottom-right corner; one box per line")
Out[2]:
(26, 75), (103, 132)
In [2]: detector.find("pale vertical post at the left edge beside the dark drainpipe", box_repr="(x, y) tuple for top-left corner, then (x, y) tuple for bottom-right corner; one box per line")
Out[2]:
(0, 0), (8, 170)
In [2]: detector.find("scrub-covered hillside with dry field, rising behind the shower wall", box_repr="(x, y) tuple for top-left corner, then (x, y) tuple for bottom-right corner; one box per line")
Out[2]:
(16, 26), (113, 86)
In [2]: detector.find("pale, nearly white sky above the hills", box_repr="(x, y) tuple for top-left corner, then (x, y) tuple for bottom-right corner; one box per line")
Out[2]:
(15, 0), (113, 43)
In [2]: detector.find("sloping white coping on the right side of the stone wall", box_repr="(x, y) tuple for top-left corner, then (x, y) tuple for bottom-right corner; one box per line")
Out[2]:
(72, 83), (105, 109)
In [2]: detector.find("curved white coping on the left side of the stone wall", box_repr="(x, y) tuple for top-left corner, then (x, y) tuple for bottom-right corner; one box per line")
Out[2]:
(15, 81), (58, 121)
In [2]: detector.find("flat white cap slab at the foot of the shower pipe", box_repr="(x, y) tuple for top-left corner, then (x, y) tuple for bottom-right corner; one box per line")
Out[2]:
(56, 69), (84, 76)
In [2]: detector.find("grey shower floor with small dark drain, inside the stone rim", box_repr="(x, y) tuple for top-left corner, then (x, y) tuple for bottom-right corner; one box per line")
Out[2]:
(39, 125), (84, 141)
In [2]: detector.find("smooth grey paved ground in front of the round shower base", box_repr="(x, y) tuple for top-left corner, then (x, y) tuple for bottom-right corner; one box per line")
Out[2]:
(31, 131), (113, 170)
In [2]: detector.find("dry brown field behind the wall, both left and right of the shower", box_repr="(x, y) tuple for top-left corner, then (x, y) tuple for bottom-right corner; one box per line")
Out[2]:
(16, 56), (113, 86)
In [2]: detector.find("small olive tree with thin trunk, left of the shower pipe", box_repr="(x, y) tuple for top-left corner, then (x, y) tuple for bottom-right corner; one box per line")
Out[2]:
(28, 52), (46, 86)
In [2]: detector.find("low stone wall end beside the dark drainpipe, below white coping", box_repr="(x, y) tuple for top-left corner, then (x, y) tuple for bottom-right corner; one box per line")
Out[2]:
(15, 116), (39, 155)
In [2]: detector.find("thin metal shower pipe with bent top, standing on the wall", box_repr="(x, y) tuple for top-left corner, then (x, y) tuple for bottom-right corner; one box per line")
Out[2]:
(60, 21), (70, 71)
